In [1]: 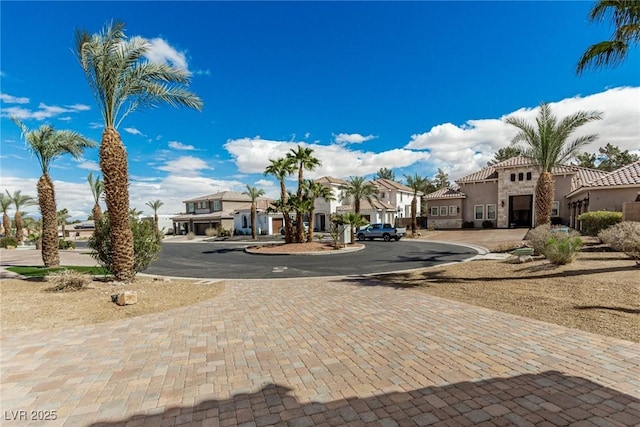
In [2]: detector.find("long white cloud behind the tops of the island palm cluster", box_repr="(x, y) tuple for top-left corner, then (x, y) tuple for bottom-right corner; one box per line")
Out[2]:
(224, 136), (430, 178)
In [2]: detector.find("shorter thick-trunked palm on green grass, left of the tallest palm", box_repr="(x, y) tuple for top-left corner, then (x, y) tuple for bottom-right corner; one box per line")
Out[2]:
(13, 117), (97, 267)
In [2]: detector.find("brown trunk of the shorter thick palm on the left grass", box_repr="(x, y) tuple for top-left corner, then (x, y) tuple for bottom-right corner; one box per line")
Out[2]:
(38, 174), (60, 267)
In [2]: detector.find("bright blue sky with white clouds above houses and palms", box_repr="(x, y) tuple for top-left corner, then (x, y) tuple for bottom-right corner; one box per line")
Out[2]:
(0, 1), (640, 219)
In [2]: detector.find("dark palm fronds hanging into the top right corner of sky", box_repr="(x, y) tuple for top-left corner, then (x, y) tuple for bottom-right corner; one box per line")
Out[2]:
(576, 0), (640, 74)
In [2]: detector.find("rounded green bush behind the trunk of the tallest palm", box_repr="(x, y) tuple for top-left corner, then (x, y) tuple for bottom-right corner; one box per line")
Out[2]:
(89, 214), (162, 273)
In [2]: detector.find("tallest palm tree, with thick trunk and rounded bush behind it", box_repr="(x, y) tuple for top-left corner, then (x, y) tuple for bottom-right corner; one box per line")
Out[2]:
(76, 22), (202, 282)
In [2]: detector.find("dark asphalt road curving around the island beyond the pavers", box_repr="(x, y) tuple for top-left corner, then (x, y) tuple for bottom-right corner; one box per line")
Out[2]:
(145, 240), (477, 279)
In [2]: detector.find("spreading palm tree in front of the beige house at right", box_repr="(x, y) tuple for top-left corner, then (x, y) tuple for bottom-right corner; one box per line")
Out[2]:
(505, 102), (602, 226)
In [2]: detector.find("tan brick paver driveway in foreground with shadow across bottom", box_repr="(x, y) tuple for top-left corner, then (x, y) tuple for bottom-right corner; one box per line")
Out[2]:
(1, 278), (640, 426)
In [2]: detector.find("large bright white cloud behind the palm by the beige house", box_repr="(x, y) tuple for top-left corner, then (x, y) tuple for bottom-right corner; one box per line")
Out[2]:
(405, 87), (640, 179)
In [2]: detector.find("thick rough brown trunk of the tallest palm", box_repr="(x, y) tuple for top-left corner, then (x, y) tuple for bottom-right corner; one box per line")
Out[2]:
(100, 127), (135, 282)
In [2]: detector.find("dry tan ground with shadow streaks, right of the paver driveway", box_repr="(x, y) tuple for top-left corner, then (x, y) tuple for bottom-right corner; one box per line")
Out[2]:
(378, 252), (640, 342)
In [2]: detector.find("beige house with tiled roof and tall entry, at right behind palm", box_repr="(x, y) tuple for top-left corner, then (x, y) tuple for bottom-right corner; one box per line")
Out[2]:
(425, 156), (640, 228)
